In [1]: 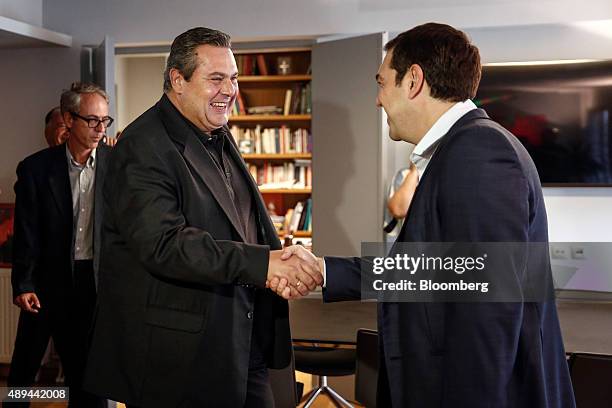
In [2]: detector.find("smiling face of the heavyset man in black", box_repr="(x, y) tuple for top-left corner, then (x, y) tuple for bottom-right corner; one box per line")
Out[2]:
(170, 45), (238, 132)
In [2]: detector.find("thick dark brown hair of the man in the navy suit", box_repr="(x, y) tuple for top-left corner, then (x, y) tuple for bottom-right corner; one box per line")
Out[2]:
(385, 23), (482, 102)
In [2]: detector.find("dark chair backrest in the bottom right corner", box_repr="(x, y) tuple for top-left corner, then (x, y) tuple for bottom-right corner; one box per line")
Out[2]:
(569, 353), (612, 408)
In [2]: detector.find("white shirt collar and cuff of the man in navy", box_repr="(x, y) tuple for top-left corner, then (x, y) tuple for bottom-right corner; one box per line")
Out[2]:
(323, 99), (476, 287)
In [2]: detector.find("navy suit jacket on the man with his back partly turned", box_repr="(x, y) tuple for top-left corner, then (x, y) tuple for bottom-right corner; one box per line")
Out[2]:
(324, 109), (574, 408)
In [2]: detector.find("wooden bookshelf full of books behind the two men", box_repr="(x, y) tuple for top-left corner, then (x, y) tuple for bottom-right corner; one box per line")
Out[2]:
(229, 47), (312, 246)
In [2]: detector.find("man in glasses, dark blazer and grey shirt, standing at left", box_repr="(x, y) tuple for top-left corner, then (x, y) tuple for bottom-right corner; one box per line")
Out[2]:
(7, 83), (113, 407)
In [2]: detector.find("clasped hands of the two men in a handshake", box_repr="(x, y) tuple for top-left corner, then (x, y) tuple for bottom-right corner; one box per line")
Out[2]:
(266, 247), (323, 299)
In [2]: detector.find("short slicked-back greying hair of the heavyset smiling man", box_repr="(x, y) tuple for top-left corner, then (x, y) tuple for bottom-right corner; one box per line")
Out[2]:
(164, 27), (232, 92)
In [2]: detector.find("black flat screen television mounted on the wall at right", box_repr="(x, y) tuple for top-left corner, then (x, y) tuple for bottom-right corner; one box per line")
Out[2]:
(474, 61), (612, 186)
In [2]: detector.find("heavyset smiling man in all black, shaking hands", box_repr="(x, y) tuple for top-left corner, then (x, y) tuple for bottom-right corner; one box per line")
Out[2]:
(86, 27), (322, 408)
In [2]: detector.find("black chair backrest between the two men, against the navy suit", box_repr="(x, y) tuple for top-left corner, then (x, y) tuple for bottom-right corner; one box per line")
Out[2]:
(355, 329), (378, 408)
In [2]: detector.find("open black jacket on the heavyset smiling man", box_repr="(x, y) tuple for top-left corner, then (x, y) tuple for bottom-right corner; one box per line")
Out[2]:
(86, 96), (291, 407)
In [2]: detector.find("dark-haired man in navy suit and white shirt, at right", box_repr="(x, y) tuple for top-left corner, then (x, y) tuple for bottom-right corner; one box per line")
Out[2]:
(271, 23), (575, 408)
